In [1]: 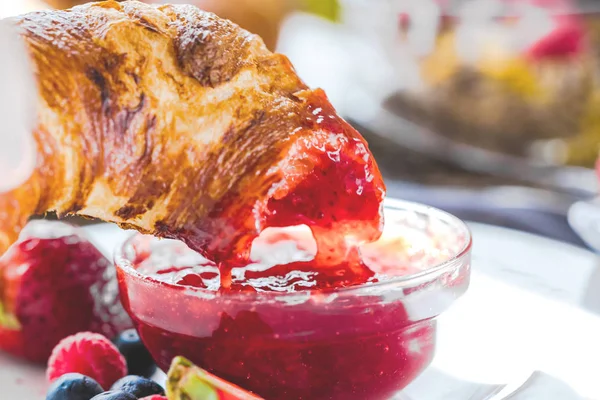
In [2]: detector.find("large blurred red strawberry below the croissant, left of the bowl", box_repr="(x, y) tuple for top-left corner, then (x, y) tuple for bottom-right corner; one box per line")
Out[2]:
(0, 221), (131, 363)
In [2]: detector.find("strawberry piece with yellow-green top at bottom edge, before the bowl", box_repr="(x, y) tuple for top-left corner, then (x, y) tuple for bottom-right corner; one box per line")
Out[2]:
(167, 357), (261, 400)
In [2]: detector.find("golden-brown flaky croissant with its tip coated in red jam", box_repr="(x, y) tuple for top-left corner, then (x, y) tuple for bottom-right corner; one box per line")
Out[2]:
(0, 1), (385, 268)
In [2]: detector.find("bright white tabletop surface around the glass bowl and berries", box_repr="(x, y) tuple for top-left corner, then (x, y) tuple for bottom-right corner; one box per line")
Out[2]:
(0, 224), (600, 400)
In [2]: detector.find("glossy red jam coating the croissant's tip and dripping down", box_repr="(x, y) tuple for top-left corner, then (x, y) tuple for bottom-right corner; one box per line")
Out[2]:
(170, 89), (385, 289)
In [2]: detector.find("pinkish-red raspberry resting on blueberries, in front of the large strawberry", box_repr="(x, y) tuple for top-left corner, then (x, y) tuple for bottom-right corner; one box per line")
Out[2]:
(46, 332), (127, 388)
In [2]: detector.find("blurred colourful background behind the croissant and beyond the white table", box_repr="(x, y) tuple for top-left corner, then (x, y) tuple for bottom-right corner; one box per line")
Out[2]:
(0, 0), (600, 246)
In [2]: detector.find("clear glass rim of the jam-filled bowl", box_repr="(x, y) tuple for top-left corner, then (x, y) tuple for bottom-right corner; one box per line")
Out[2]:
(114, 198), (473, 301)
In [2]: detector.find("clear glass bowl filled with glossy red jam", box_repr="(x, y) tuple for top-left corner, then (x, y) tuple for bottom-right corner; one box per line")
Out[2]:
(116, 201), (471, 400)
